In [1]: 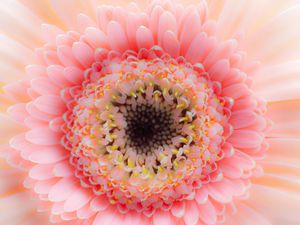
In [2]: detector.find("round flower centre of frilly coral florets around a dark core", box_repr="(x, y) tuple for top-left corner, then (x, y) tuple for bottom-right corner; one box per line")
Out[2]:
(65, 49), (231, 216)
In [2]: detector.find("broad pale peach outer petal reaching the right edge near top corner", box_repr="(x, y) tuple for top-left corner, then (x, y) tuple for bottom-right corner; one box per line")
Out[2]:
(245, 5), (300, 63)
